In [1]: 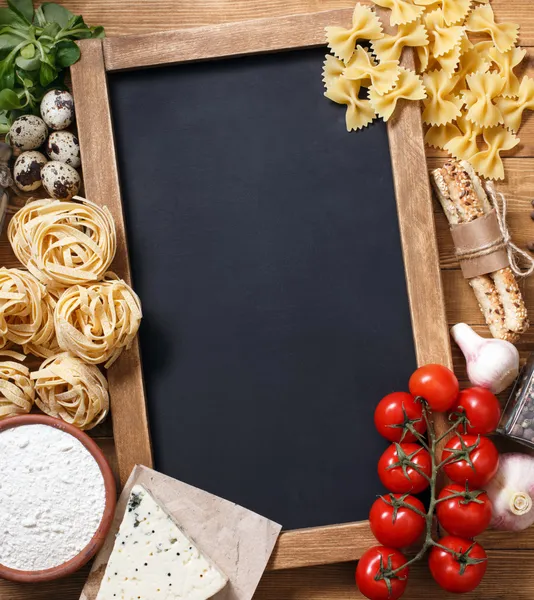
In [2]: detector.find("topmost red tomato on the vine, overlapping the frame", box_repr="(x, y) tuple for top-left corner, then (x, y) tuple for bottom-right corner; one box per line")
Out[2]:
(409, 365), (460, 412)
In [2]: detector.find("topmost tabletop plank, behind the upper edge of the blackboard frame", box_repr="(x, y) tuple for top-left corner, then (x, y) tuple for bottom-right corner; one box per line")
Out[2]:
(36, 0), (534, 46)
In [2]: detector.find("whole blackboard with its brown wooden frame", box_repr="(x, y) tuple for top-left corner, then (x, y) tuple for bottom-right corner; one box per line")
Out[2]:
(71, 9), (452, 569)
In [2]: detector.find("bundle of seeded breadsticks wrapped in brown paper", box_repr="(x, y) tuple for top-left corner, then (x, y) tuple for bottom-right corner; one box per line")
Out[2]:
(431, 160), (529, 342)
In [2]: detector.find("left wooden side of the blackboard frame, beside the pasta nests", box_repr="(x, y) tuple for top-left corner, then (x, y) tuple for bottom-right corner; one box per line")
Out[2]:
(71, 40), (152, 484)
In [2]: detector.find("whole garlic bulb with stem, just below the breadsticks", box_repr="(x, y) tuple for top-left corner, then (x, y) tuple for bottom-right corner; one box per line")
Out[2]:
(451, 323), (519, 394)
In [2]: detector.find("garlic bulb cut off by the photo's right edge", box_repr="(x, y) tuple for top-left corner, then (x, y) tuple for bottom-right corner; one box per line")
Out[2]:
(486, 452), (534, 531)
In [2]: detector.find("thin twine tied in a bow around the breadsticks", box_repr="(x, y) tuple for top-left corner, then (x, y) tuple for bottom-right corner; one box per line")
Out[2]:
(456, 181), (534, 277)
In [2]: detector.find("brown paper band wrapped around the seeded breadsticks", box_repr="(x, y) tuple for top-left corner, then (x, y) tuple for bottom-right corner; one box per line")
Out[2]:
(451, 210), (510, 279)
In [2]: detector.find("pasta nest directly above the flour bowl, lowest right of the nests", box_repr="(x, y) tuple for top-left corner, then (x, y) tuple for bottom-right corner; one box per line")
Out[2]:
(31, 352), (109, 429)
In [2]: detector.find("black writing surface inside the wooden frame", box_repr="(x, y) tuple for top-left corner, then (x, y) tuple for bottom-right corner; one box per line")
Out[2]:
(108, 49), (418, 529)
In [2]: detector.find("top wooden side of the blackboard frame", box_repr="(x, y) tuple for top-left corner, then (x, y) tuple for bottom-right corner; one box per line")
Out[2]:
(103, 9), (352, 71)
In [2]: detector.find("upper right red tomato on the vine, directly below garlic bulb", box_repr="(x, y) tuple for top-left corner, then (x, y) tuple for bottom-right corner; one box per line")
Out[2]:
(453, 386), (501, 435)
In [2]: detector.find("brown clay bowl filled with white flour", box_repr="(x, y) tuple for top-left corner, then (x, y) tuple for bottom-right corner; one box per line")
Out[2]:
(0, 415), (116, 582)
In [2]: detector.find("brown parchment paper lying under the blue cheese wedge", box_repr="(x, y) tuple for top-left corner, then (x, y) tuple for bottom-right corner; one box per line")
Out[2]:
(80, 465), (282, 600)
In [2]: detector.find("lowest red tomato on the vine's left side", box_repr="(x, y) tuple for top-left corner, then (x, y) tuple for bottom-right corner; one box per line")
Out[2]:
(356, 546), (408, 600)
